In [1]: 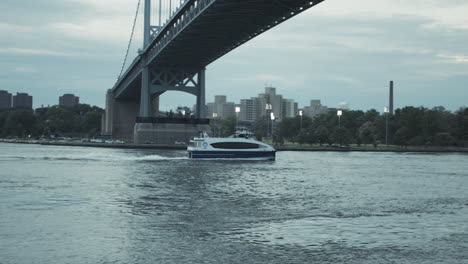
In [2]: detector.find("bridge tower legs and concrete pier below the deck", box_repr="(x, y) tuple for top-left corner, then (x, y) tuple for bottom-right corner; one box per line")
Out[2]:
(133, 67), (210, 145)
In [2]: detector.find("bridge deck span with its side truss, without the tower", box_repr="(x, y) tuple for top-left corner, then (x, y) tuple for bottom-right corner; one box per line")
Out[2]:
(112, 0), (323, 101)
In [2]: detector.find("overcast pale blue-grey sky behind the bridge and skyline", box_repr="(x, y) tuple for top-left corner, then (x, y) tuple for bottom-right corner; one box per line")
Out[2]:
(0, 0), (468, 111)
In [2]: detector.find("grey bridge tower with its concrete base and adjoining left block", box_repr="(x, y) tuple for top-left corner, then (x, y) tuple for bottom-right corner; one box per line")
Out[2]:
(103, 0), (210, 144)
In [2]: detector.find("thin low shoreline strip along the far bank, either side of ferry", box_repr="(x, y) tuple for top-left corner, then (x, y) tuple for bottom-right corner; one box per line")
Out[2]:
(0, 140), (468, 154)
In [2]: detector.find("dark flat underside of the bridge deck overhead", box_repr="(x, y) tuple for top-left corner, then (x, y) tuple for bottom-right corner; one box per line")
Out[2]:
(115, 0), (322, 100)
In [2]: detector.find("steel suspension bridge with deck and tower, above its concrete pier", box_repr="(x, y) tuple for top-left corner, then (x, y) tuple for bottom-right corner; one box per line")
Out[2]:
(108, 0), (323, 142)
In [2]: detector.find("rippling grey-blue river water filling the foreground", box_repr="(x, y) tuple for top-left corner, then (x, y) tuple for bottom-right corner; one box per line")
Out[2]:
(0, 144), (468, 264)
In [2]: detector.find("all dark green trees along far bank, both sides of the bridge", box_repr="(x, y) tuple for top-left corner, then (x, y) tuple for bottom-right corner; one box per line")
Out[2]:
(0, 104), (468, 147)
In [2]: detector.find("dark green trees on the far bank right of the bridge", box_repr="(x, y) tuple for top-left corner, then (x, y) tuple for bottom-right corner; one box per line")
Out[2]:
(212, 106), (468, 147)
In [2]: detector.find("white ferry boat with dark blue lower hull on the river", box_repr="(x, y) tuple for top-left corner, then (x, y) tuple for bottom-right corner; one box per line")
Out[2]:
(187, 130), (276, 160)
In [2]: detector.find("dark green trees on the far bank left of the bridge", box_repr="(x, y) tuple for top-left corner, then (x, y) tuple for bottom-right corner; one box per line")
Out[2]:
(0, 104), (104, 138)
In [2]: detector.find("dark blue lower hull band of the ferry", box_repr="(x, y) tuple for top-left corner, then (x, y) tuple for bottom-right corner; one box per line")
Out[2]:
(189, 151), (275, 160)
